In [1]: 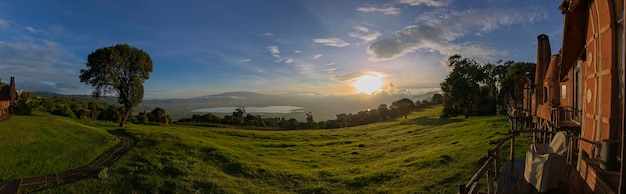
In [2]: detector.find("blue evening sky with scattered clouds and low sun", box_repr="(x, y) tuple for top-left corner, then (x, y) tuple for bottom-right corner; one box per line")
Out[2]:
(0, 0), (563, 99)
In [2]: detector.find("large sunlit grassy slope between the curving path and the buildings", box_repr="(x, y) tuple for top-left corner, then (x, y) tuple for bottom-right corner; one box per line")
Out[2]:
(44, 107), (526, 193)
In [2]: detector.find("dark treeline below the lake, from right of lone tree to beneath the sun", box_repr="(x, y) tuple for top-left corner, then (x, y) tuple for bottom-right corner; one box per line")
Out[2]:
(176, 94), (443, 130)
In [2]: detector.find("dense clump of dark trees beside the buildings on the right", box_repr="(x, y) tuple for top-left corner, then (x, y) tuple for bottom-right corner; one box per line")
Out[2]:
(441, 55), (535, 117)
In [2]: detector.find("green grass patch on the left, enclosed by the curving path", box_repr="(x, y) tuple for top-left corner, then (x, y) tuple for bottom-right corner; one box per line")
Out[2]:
(0, 113), (119, 180)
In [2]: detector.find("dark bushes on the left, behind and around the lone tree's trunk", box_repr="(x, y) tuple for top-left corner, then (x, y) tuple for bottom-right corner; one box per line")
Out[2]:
(15, 92), (170, 124)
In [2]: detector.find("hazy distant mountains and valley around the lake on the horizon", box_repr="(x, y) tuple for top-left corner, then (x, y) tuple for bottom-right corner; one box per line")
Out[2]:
(29, 91), (437, 121)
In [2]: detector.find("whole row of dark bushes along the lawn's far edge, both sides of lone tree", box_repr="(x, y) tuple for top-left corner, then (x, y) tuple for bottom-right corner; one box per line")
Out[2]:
(15, 92), (444, 130)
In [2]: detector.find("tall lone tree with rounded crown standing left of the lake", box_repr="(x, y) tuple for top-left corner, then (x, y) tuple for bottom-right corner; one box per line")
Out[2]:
(80, 44), (152, 127)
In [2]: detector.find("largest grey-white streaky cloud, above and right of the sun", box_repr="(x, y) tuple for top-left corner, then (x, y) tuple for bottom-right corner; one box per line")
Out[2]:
(368, 8), (541, 61)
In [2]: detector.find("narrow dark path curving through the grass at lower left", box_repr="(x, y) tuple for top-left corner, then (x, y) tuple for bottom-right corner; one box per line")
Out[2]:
(0, 129), (137, 194)
